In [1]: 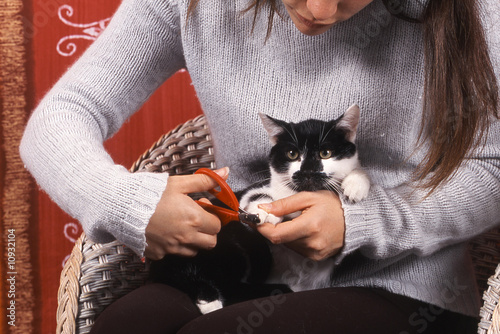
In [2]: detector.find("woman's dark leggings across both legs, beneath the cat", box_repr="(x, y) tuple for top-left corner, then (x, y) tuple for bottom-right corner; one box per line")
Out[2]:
(91, 284), (477, 334)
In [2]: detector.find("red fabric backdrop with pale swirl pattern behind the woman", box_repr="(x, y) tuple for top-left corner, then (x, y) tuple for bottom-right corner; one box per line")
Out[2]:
(27, 0), (201, 333)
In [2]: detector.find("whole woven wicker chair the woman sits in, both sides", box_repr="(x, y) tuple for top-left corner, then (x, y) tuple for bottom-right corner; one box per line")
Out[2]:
(56, 116), (500, 334)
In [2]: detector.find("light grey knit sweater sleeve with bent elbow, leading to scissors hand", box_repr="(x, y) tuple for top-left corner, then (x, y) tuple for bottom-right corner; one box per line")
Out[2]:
(20, 0), (184, 254)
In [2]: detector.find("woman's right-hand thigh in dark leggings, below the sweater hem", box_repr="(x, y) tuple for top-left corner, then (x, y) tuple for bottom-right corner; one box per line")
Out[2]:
(178, 288), (475, 334)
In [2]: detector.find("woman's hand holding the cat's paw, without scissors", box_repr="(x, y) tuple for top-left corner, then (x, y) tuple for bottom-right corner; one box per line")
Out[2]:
(257, 190), (345, 261)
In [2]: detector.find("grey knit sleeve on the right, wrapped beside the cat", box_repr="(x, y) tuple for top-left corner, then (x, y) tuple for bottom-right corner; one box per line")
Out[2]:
(337, 139), (500, 262)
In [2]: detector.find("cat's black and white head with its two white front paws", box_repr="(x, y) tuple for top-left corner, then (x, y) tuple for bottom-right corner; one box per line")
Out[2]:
(240, 105), (370, 224)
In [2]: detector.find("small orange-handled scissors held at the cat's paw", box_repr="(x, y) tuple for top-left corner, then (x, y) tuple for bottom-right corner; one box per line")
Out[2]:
(194, 168), (260, 226)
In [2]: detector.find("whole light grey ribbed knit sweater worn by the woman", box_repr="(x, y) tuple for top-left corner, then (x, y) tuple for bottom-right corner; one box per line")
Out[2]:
(21, 0), (500, 315)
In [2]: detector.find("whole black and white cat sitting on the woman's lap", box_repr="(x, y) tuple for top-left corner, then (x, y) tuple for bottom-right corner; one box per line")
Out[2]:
(147, 105), (370, 313)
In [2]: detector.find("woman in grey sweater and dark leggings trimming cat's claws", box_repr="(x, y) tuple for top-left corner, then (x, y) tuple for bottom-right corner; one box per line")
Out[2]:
(21, 0), (500, 333)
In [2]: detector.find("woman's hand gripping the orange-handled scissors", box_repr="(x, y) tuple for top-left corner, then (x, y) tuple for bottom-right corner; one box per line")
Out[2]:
(145, 168), (229, 260)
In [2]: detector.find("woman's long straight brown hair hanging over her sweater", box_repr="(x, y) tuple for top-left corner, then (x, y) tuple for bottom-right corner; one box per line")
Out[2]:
(188, 0), (499, 192)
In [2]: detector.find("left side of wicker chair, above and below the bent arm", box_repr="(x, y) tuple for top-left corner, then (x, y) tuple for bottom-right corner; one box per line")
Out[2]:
(56, 116), (215, 334)
